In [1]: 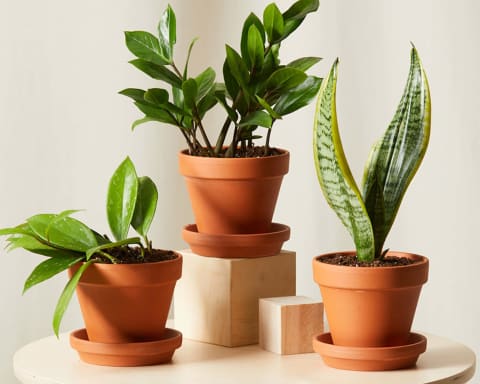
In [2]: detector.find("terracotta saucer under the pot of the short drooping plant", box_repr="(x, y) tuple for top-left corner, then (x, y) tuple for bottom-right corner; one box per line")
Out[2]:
(70, 328), (182, 367)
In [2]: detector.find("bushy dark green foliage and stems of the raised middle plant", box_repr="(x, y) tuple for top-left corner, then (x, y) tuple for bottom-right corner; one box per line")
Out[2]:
(120, 0), (321, 157)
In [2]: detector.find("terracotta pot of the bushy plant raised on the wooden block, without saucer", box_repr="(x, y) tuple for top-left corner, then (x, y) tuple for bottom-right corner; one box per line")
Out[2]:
(179, 150), (290, 234)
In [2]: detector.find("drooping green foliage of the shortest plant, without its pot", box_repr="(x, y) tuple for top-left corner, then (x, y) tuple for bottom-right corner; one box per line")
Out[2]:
(0, 157), (162, 336)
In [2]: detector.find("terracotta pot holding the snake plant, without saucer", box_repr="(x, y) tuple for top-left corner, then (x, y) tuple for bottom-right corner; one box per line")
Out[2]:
(313, 252), (428, 347)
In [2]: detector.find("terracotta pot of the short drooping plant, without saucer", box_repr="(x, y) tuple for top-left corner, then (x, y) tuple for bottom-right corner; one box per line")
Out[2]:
(69, 254), (183, 343)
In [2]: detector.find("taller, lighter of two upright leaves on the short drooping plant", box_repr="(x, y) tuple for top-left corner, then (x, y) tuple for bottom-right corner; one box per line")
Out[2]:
(107, 157), (138, 240)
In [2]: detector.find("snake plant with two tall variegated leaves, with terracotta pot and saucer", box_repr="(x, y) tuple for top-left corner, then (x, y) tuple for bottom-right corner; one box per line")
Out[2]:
(313, 47), (430, 370)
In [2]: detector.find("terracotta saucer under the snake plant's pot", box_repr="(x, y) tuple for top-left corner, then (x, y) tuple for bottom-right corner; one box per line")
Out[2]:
(313, 333), (427, 371)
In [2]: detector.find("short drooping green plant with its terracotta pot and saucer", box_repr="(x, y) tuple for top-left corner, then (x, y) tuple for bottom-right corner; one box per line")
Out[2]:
(0, 157), (182, 366)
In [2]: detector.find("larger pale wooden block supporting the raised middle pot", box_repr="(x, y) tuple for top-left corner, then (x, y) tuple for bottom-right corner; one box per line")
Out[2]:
(174, 250), (296, 347)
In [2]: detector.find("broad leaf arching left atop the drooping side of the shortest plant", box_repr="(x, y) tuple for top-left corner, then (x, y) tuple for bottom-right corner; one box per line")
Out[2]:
(27, 214), (98, 252)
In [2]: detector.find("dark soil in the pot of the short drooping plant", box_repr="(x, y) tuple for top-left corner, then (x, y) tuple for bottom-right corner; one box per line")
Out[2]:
(95, 247), (178, 264)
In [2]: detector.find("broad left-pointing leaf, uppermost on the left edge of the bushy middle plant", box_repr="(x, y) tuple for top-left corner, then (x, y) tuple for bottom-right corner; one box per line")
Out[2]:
(125, 31), (169, 65)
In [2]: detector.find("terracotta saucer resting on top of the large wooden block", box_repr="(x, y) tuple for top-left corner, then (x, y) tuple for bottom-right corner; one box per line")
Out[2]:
(182, 223), (290, 259)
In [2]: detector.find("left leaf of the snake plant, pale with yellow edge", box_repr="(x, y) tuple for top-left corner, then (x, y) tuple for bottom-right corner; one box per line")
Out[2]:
(313, 60), (375, 260)
